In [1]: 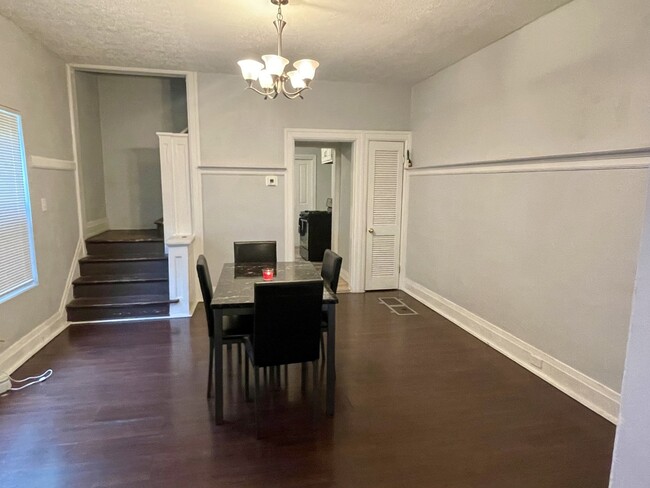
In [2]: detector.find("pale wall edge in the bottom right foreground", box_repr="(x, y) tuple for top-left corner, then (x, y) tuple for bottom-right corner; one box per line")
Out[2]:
(610, 174), (650, 488)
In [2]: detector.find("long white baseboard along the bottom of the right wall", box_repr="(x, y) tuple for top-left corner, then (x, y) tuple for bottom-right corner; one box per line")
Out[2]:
(403, 278), (620, 424)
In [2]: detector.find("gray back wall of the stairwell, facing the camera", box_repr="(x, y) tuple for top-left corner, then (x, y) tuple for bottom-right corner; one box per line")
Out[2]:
(99, 75), (187, 229)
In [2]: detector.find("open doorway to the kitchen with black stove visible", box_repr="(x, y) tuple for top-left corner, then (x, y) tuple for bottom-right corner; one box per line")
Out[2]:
(293, 141), (352, 292)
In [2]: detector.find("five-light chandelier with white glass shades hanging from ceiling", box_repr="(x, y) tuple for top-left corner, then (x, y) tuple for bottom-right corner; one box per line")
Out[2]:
(237, 0), (318, 100)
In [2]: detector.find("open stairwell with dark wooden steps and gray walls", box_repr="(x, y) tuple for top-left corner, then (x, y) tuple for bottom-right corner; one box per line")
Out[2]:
(66, 66), (196, 322)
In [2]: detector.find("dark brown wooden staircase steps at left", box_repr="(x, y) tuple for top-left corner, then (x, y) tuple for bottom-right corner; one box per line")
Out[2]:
(66, 230), (176, 322)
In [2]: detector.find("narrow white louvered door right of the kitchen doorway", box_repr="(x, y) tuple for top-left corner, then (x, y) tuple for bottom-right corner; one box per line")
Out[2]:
(366, 141), (404, 290)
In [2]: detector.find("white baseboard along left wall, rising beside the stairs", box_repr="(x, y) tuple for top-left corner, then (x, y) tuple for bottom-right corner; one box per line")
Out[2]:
(0, 238), (83, 374)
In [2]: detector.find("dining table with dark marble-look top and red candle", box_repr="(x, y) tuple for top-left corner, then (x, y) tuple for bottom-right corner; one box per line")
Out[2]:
(210, 261), (339, 424)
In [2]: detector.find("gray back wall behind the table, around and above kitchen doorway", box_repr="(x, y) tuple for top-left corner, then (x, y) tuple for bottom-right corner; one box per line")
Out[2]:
(198, 73), (410, 270)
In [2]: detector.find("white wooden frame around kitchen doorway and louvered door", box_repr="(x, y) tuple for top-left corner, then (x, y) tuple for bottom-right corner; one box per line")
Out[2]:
(284, 129), (411, 293)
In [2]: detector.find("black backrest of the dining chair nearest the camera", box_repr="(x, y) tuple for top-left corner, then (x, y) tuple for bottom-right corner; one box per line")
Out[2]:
(253, 280), (323, 366)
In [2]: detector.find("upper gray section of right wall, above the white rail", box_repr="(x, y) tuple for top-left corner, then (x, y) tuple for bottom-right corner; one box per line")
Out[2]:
(411, 0), (650, 165)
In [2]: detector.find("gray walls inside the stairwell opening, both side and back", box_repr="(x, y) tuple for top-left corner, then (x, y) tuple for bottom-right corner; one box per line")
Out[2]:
(74, 69), (188, 238)
